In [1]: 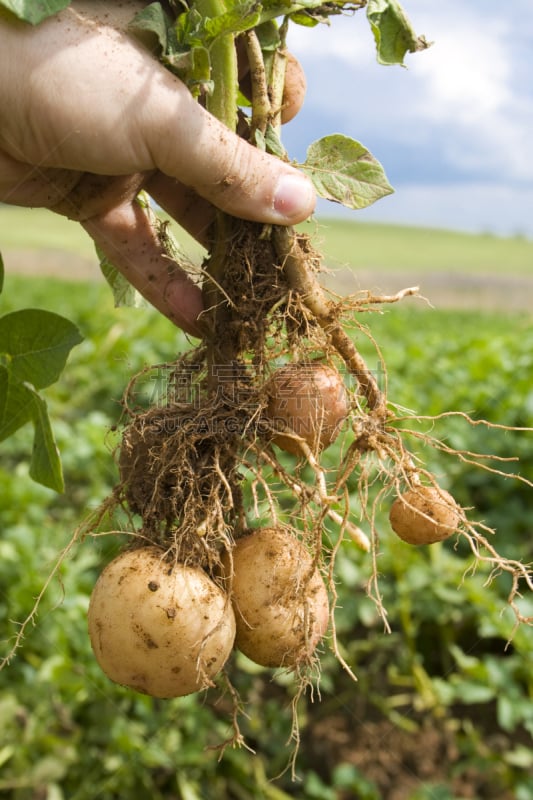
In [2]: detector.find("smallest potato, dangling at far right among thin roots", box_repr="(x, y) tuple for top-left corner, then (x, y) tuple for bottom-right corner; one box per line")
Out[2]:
(389, 486), (461, 544)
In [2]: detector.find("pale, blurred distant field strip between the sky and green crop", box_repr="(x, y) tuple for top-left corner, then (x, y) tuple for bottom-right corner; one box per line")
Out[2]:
(4, 206), (533, 311)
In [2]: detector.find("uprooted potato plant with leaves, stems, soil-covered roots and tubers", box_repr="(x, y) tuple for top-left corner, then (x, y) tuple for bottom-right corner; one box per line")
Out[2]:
(0, 0), (533, 764)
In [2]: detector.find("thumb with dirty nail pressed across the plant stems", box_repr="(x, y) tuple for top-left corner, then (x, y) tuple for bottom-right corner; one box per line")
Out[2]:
(142, 79), (316, 225)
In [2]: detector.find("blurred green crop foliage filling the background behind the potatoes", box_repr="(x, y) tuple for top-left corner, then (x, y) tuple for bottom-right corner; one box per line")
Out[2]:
(0, 277), (533, 800)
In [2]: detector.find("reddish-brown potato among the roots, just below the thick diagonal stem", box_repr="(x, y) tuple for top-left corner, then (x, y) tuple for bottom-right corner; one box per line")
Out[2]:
(265, 362), (349, 454)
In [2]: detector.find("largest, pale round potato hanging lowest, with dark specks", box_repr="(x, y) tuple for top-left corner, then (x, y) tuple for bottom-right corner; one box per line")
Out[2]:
(88, 547), (235, 697)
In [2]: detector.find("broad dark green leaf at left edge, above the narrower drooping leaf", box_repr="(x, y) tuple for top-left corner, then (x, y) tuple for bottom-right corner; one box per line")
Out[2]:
(0, 308), (83, 389)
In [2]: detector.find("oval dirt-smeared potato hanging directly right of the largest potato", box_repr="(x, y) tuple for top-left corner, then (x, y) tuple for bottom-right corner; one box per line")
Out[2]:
(224, 528), (329, 667)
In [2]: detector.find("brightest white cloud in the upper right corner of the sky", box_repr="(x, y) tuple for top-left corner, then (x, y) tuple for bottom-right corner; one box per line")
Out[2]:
(404, 2), (533, 181)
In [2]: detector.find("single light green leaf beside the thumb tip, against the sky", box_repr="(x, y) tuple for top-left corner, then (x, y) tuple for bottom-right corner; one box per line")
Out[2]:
(302, 133), (394, 209)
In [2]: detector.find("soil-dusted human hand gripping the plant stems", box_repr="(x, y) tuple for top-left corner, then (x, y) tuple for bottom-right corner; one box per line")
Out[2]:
(0, 0), (315, 335)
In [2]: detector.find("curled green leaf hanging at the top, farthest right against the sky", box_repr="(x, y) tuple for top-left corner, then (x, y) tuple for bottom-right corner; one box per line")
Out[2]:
(366, 0), (429, 65)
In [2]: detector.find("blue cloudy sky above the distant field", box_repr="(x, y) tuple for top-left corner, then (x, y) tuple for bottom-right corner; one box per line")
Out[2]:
(283, 0), (533, 238)
